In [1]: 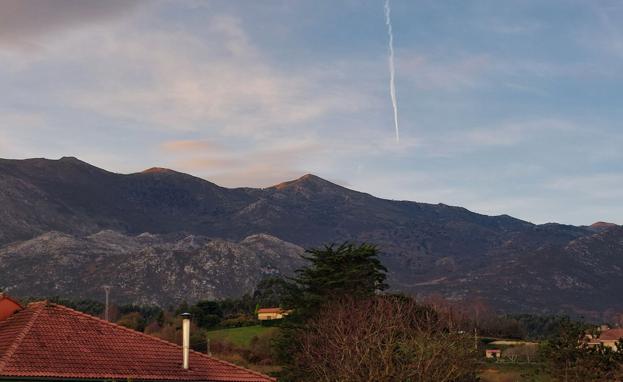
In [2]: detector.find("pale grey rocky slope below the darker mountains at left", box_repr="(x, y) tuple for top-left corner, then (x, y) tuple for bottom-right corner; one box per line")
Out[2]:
(0, 231), (303, 306)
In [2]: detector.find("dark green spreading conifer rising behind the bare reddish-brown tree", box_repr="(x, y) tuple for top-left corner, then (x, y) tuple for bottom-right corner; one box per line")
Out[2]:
(289, 243), (387, 317)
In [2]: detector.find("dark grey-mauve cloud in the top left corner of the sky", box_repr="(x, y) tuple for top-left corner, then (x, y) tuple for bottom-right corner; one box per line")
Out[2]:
(0, 0), (139, 45)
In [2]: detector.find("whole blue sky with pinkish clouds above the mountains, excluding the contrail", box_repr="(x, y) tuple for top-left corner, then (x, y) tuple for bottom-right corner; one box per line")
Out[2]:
(0, 0), (623, 225)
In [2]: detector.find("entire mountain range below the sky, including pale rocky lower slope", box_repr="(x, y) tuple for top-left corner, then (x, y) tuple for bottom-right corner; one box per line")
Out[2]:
(0, 157), (623, 316)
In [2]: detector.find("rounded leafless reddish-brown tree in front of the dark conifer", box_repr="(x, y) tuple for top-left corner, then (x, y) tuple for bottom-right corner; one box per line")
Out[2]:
(283, 296), (478, 382)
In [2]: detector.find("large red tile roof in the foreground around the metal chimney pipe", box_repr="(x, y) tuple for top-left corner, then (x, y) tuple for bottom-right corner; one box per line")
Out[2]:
(0, 302), (275, 382)
